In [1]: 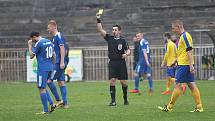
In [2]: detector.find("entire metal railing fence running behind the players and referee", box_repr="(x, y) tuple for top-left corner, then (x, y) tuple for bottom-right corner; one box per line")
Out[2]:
(0, 45), (215, 81)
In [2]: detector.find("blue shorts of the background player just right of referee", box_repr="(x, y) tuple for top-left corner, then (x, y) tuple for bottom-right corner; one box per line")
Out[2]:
(135, 64), (151, 75)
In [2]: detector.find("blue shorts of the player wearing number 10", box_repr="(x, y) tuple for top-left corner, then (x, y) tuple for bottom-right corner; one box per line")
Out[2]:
(37, 71), (51, 89)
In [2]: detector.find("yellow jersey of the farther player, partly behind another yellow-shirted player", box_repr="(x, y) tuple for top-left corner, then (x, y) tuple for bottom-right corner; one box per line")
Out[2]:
(164, 40), (177, 66)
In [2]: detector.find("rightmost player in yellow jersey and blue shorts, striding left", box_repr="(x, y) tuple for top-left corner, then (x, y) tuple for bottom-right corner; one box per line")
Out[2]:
(158, 20), (203, 112)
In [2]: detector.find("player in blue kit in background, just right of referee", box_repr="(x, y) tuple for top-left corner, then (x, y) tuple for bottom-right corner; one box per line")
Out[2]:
(130, 33), (153, 95)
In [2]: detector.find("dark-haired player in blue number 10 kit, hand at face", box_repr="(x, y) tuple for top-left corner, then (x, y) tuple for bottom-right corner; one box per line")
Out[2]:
(28, 32), (55, 114)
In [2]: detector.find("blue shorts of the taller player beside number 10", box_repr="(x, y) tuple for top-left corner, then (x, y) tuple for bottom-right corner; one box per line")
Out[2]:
(50, 64), (67, 81)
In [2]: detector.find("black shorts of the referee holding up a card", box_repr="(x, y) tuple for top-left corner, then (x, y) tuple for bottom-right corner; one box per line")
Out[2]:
(108, 60), (128, 80)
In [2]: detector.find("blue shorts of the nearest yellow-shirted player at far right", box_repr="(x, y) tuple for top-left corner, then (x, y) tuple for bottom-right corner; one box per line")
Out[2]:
(176, 65), (194, 83)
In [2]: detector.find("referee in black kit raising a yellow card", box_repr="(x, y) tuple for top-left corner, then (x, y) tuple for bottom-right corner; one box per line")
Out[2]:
(96, 13), (131, 106)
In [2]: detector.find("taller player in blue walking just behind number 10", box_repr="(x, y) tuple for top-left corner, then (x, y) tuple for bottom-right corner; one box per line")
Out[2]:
(47, 20), (69, 108)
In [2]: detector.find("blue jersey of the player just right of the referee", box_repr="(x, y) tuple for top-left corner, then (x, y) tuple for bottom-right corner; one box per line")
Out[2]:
(138, 39), (150, 65)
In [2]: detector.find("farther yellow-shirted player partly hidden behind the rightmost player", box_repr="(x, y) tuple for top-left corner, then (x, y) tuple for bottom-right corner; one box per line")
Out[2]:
(161, 33), (186, 95)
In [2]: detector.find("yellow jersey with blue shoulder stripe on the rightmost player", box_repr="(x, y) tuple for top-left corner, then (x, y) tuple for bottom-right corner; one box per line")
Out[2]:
(177, 32), (194, 65)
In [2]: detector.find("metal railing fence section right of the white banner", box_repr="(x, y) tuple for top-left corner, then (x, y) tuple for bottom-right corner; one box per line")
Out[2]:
(84, 46), (215, 80)
